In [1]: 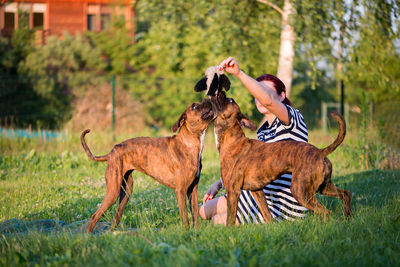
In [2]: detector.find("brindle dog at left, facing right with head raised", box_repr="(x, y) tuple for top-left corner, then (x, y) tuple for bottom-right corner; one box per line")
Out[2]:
(81, 99), (214, 232)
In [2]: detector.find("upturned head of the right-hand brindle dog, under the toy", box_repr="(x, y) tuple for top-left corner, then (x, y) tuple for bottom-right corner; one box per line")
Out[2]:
(211, 92), (257, 134)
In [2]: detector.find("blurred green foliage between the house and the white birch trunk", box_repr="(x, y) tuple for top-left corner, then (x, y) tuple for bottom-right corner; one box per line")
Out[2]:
(125, 1), (280, 126)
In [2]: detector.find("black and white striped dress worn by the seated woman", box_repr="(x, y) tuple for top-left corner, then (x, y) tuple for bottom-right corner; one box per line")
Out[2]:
(236, 105), (308, 224)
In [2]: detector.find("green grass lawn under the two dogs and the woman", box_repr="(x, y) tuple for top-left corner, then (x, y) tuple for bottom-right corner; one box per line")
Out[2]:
(0, 129), (400, 266)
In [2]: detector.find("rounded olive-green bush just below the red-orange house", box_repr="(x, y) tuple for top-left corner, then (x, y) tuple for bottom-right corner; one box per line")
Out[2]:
(18, 33), (105, 127)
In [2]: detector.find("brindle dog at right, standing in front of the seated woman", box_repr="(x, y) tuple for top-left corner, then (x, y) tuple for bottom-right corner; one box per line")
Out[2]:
(212, 92), (352, 225)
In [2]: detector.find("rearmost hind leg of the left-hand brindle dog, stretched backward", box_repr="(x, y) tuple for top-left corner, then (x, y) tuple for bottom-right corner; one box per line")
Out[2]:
(87, 165), (122, 233)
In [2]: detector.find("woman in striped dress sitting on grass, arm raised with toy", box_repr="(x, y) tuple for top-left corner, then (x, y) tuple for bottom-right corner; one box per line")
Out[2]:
(200, 57), (308, 225)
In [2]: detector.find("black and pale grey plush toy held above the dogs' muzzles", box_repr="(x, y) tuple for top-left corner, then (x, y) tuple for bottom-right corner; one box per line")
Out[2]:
(194, 66), (231, 96)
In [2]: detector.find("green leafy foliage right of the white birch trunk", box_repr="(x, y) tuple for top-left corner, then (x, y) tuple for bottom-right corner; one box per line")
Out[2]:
(295, 0), (400, 104)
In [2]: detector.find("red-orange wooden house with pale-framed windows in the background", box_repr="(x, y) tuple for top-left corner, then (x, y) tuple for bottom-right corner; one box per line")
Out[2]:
(0, 0), (137, 44)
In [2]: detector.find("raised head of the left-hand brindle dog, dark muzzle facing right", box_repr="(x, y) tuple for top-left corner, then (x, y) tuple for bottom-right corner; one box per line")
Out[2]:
(172, 99), (215, 133)
